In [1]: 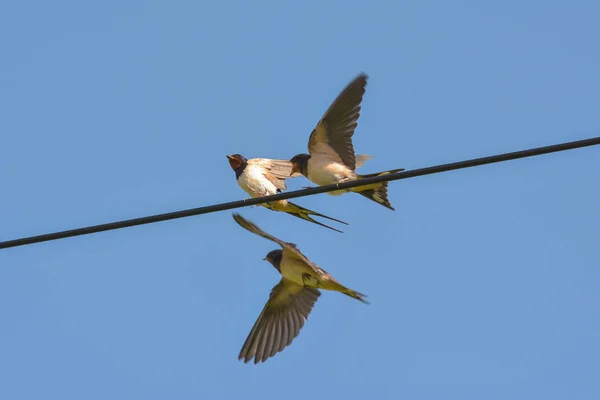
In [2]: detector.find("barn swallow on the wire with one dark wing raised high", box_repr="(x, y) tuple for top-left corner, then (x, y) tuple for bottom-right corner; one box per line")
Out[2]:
(290, 74), (404, 210)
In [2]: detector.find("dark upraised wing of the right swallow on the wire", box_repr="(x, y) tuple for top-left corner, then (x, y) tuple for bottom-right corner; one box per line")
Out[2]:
(308, 74), (367, 171)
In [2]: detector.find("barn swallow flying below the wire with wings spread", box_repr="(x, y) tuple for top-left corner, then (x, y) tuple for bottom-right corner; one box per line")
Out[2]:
(233, 213), (369, 364)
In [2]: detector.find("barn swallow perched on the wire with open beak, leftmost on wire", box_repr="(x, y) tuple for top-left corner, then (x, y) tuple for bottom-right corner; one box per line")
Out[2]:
(227, 154), (348, 232)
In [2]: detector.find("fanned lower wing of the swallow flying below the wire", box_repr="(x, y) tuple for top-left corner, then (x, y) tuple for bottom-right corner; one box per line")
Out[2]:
(239, 278), (321, 364)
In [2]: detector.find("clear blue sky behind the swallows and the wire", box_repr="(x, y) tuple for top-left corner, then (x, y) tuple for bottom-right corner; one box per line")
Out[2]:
(0, 0), (600, 400)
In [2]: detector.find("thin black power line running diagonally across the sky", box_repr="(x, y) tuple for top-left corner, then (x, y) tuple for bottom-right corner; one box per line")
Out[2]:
(0, 137), (600, 249)
